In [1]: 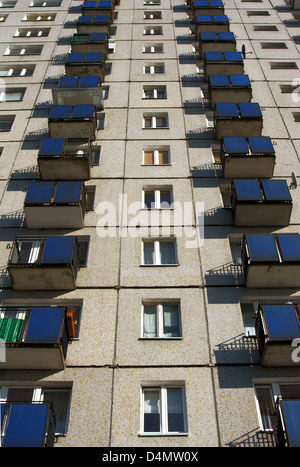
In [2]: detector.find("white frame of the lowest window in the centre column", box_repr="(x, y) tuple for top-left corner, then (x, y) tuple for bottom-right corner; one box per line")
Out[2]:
(140, 382), (188, 436)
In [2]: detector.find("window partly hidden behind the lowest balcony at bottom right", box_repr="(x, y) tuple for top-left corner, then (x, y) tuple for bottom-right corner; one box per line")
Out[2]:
(255, 383), (300, 430)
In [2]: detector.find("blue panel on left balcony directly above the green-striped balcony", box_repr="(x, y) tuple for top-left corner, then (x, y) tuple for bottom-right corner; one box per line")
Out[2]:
(41, 236), (75, 264)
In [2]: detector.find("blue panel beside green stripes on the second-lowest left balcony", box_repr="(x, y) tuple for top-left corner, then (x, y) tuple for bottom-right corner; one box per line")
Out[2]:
(24, 307), (64, 344)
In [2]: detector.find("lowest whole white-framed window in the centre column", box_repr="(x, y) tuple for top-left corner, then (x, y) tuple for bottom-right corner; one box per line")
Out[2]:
(142, 385), (187, 434)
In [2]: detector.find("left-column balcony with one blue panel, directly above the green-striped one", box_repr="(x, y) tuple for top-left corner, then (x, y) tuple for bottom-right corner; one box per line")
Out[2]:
(8, 236), (82, 290)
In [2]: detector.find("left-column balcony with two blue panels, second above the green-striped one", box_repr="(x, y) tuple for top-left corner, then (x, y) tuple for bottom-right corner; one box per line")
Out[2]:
(24, 181), (87, 229)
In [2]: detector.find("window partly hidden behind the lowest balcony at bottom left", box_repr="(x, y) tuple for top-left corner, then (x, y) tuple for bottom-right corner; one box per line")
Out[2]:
(0, 386), (71, 436)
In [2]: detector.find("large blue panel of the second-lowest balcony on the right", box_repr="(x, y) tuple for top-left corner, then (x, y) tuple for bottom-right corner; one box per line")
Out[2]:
(262, 305), (300, 340)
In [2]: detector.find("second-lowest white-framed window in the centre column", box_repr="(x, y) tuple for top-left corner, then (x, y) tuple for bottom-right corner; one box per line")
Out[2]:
(142, 302), (181, 338)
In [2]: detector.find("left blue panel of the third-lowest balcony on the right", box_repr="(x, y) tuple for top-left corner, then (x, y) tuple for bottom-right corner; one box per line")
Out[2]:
(246, 234), (279, 262)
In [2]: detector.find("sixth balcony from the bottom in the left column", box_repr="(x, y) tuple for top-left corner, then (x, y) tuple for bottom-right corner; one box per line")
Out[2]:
(48, 104), (97, 141)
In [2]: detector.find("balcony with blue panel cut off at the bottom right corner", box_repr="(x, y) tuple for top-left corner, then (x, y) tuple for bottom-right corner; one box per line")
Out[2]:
(273, 398), (300, 448)
